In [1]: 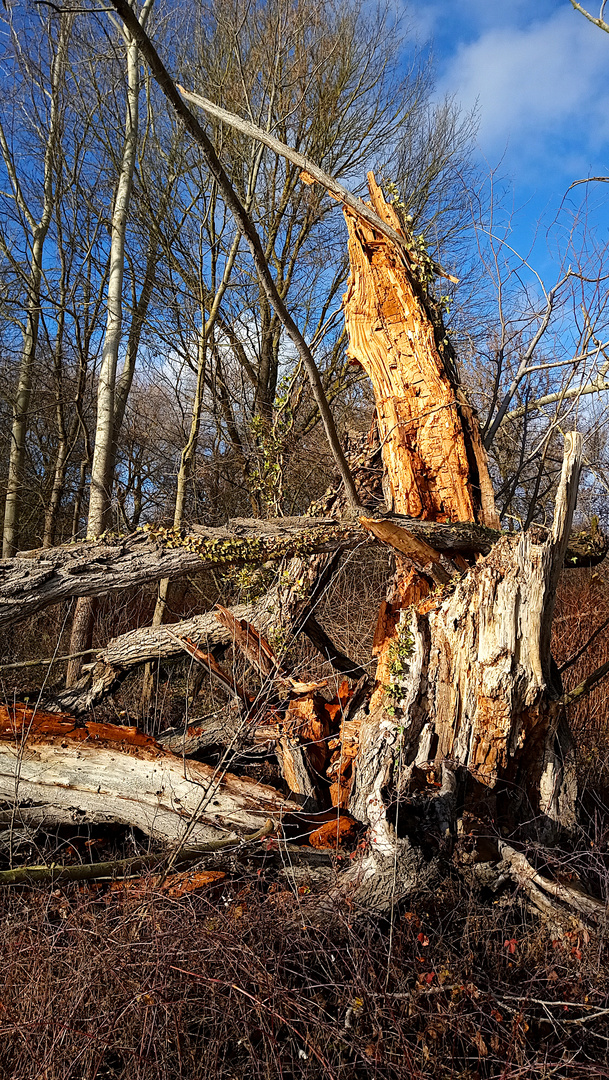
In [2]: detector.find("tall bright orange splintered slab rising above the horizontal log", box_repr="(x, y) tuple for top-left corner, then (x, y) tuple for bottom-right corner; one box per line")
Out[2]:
(344, 173), (497, 526)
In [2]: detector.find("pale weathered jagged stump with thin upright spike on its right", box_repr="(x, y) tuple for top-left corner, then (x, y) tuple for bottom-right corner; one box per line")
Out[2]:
(349, 433), (582, 836)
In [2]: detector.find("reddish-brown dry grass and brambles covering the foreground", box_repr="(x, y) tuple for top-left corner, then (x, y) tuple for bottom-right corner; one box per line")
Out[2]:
(0, 851), (609, 1080)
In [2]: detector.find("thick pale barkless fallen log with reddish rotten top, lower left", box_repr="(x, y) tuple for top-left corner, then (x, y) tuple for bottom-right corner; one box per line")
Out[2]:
(0, 705), (299, 846)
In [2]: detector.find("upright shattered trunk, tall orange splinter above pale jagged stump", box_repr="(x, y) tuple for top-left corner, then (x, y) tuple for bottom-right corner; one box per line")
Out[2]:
(337, 174), (581, 899)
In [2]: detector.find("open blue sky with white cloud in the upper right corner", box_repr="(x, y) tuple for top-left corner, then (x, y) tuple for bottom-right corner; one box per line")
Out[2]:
(406, 0), (609, 276)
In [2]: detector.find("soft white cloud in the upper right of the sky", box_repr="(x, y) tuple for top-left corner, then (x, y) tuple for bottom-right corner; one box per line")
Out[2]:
(436, 0), (609, 172)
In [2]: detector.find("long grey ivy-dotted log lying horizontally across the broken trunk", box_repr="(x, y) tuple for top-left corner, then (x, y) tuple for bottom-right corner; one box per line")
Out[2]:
(0, 515), (590, 627)
